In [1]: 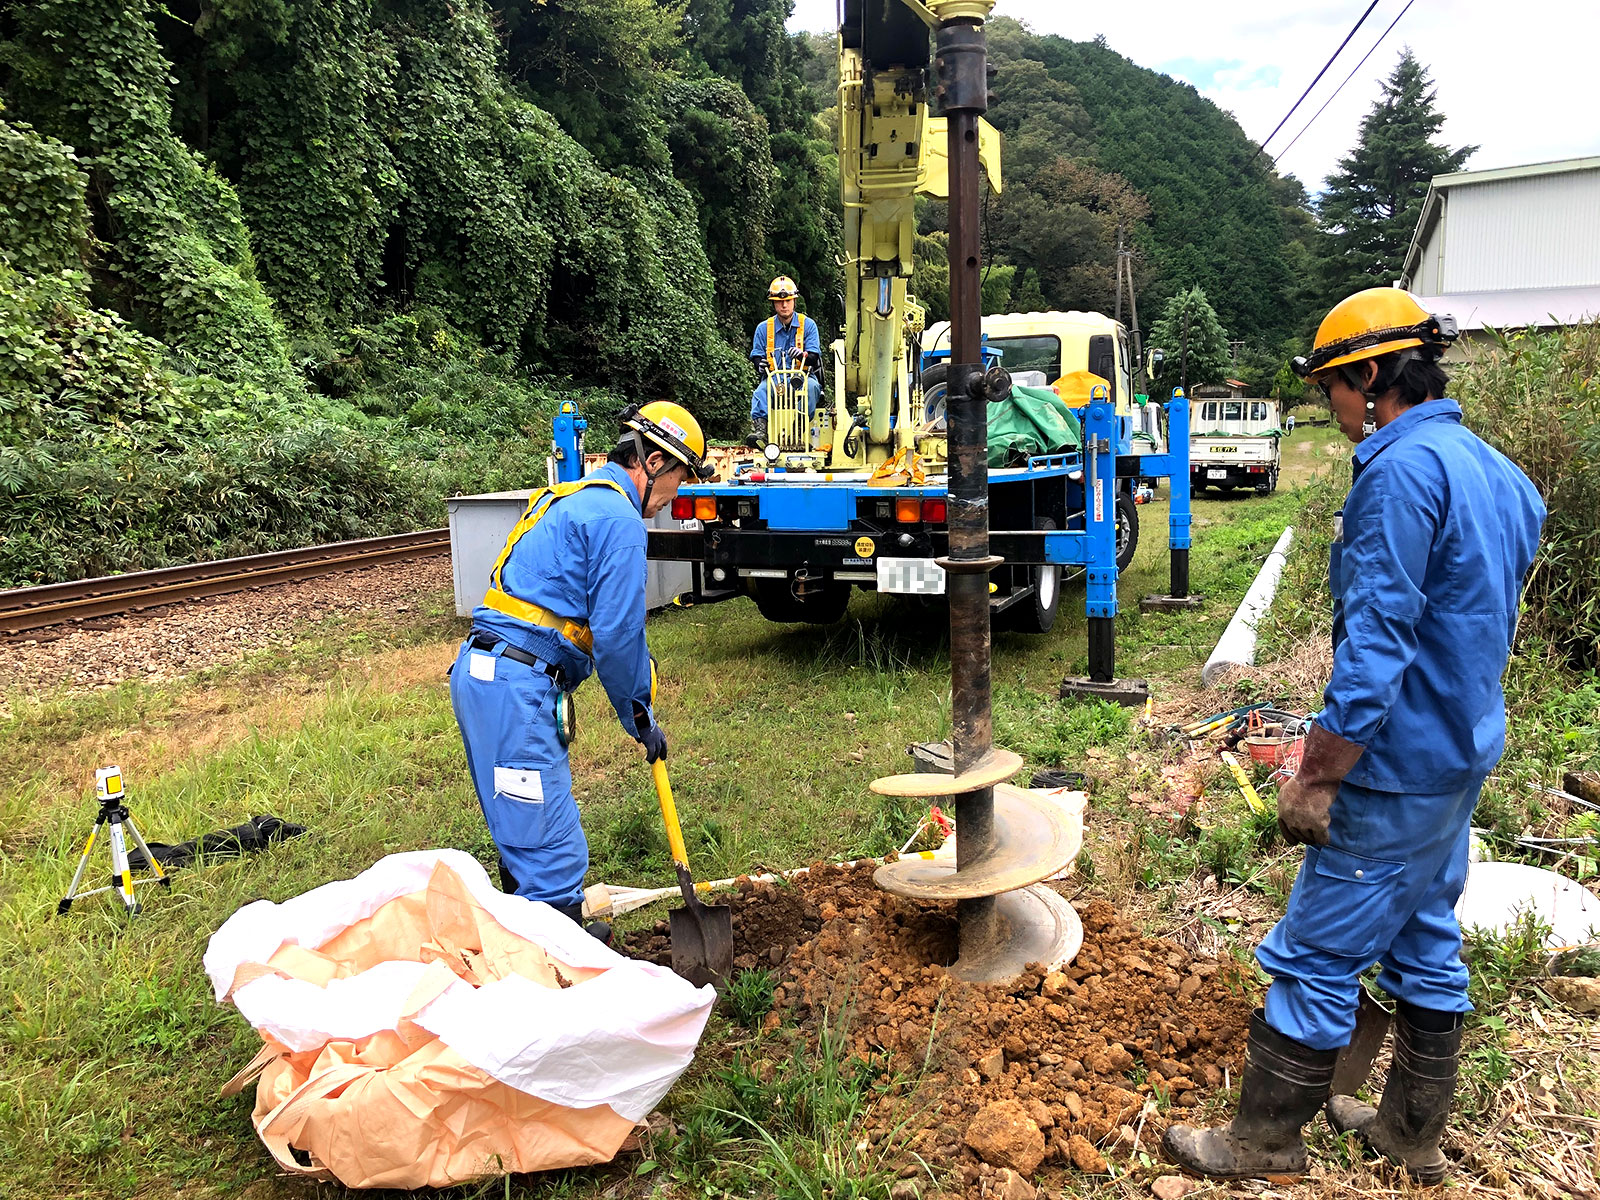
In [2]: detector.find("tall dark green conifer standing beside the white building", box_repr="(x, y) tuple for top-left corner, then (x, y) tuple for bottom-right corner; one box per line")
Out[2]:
(1317, 46), (1478, 299)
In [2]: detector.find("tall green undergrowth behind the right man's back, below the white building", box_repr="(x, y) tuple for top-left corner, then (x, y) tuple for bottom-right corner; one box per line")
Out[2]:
(1451, 323), (1600, 670)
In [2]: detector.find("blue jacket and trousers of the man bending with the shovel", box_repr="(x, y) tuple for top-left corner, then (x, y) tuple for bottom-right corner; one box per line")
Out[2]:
(450, 464), (654, 907)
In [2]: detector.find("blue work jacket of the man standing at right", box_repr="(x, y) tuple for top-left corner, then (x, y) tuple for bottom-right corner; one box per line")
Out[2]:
(1317, 400), (1544, 795)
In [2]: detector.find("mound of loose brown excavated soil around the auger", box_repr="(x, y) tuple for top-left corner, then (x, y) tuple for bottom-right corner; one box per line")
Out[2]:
(629, 866), (1256, 1190)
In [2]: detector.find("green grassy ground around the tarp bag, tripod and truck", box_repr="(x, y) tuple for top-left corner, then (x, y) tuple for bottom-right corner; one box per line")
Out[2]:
(0, 429), (1600, 1200)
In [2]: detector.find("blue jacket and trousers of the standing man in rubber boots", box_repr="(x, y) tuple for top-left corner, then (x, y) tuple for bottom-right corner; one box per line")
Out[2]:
(1256, 400), (1544, 1050)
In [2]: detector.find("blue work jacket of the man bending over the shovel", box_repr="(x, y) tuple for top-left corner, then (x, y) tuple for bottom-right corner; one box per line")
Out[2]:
(472, 462), (654, 736)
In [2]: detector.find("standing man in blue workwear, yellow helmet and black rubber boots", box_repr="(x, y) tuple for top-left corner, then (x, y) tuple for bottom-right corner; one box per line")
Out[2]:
(1165, 288), (1544, 1184)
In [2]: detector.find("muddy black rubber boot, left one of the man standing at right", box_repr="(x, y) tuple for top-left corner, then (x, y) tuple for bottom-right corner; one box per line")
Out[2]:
(1162, 1008), (1339, 1182)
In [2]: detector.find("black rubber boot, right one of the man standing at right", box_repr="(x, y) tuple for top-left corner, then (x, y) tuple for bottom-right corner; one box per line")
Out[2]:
(1328, 1000), (1461, 1184)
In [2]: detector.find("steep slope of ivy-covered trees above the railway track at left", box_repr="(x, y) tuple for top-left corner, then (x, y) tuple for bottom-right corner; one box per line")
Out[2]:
(0, 0), (837, 586)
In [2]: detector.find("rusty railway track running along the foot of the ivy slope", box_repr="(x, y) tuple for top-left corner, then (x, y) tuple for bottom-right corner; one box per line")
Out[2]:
(0, 530), (450, 637)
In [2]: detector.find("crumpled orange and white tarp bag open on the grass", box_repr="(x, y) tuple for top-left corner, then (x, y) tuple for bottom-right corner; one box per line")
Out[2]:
(205, 850), (715, 1187)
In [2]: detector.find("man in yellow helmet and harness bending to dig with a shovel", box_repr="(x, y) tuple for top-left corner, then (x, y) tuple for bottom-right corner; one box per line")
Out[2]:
(450, 400), (710, 941)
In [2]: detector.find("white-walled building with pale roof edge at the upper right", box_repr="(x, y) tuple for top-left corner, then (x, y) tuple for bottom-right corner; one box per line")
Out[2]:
(1398, 157), (1600, 358)
